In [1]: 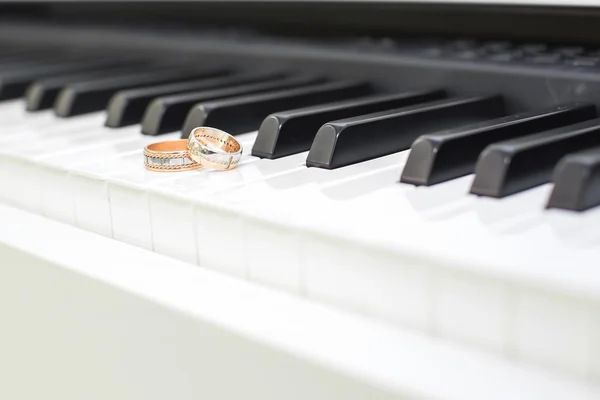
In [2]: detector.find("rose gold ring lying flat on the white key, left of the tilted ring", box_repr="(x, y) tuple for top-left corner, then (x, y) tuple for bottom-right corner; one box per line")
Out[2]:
(144, 140), (201, 172)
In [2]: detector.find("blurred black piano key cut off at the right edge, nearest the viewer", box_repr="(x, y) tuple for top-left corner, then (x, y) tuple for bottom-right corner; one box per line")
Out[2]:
(547, 147), (600, 211)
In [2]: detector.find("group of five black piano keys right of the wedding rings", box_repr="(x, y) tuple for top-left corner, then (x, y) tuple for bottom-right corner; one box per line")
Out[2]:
(260, 92), (600, 211)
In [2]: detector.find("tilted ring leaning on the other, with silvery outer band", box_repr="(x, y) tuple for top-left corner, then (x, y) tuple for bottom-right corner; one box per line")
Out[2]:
(188, 127), (243, 170)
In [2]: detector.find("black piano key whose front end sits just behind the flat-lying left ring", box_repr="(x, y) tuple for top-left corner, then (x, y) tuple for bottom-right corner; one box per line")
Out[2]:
(142, 76), (321, 137)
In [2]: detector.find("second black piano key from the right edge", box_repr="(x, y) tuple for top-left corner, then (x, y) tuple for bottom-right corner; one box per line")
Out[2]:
(471, 119), (600, 198)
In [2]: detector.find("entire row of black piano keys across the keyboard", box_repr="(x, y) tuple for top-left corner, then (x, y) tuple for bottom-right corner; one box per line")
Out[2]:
(0, 45), (600, 210)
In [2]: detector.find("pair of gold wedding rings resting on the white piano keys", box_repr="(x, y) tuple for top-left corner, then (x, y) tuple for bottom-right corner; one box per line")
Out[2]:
(144, 127), (243, 172)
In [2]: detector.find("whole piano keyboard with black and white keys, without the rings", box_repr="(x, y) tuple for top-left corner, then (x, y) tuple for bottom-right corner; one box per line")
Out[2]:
(0, 19), (600, 394)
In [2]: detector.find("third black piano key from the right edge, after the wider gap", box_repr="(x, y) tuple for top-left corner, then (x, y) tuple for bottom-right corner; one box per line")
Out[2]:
(400, 103), (596, 186)
